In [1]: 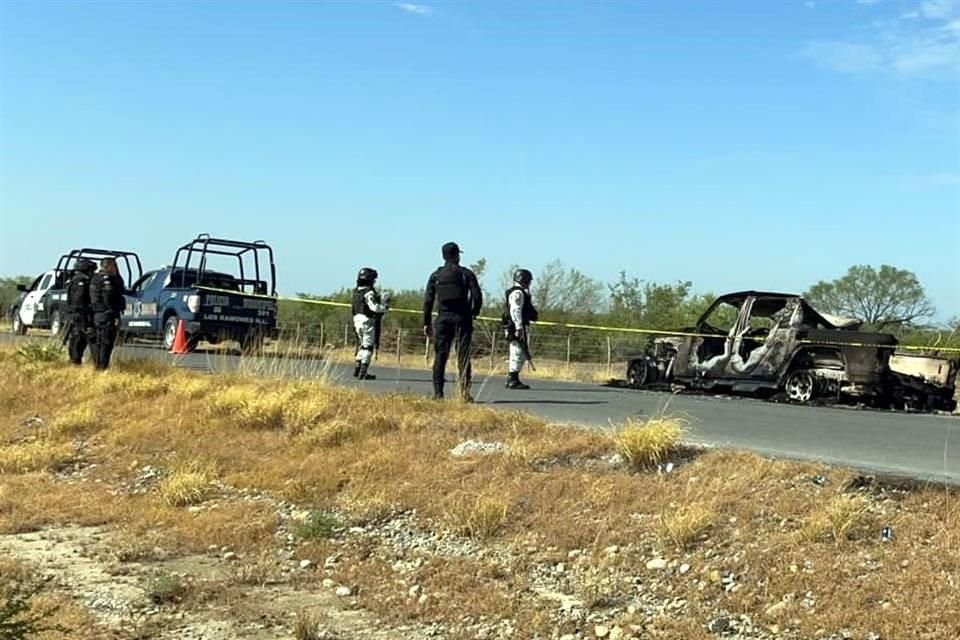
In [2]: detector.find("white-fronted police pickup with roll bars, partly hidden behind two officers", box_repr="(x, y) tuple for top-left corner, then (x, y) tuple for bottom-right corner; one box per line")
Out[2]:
(9, 248), (143, 336)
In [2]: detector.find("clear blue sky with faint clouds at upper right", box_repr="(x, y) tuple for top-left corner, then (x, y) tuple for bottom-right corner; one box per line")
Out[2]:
(0, 0), (960, 319)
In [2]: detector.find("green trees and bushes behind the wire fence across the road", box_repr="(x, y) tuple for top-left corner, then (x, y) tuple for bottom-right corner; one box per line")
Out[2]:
(0, 258), (960, 346)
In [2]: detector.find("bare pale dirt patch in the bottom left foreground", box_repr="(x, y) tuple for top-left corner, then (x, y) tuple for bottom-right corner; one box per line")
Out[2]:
(0, 526), (430, 640)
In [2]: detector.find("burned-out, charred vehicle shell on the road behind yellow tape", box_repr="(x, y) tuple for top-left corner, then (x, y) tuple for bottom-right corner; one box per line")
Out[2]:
(627, 291), (957, 411)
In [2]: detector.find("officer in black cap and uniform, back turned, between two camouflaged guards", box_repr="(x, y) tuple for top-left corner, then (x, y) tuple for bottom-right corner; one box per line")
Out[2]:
(423, 242), (483, 402)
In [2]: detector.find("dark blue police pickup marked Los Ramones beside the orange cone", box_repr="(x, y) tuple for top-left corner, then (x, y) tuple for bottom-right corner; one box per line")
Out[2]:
(120, 234), (277, 351)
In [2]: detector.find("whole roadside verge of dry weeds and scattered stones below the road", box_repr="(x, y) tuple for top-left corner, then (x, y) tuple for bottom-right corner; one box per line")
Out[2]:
(0, 349), (960, 639)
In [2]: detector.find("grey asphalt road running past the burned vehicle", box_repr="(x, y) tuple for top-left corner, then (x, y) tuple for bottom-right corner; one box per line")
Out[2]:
(4, 334), (960, 484)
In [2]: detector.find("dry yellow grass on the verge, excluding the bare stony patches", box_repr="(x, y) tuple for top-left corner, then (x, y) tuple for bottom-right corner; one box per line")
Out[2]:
(0, 348), (960, 638)
